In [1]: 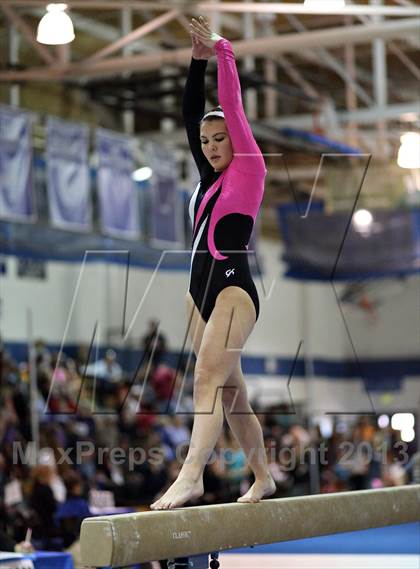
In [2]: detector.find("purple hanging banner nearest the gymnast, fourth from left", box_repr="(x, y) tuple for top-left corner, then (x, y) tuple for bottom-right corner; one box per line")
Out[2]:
(145, 142), (183, 249)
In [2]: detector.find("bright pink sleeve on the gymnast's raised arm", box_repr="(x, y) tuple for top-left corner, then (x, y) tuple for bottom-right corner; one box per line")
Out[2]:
(215, 38), (266, 174)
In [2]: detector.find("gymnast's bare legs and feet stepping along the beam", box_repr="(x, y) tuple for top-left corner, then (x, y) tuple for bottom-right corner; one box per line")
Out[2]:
(151, 286), (276, 510)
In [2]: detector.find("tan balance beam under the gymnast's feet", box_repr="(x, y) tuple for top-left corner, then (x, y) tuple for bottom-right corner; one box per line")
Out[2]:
(81, 485), (420, 567)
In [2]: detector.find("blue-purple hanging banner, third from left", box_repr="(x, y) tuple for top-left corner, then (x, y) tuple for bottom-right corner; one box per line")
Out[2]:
(96, 129), (139, 239)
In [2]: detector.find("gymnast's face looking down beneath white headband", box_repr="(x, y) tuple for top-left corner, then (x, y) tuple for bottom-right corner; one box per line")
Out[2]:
(200, 119), (233, 172)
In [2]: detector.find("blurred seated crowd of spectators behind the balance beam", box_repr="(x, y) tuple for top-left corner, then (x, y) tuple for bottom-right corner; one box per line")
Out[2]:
(0, 322), (411, 558)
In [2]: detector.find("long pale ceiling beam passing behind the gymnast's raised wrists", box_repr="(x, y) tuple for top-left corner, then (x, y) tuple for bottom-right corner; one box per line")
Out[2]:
(0, 18), (420, 81)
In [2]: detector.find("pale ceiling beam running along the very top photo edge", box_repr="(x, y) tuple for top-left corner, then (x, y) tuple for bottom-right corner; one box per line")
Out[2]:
(2, 0), (420, 17)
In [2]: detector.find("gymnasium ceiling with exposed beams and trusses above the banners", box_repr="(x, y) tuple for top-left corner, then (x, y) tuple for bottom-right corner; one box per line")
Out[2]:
(0, 0), (420, 235)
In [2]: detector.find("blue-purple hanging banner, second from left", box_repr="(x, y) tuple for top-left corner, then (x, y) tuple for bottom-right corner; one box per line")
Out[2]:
(47, 117), (92, 231)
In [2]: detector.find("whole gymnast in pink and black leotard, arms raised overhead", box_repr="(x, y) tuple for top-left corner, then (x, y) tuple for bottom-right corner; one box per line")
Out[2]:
(151, 17), (276, 510)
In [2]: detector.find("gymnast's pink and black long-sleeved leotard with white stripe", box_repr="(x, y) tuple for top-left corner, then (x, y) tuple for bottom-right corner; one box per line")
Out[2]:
(183, 39), (266, 322)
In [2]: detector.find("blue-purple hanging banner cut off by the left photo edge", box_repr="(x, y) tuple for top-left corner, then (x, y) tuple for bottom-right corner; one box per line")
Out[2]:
(0, 106), (36, 221)
